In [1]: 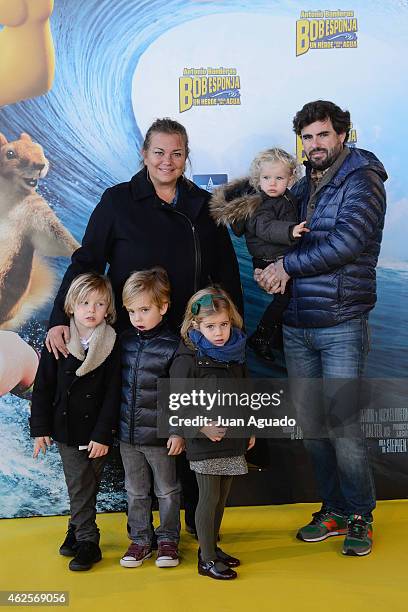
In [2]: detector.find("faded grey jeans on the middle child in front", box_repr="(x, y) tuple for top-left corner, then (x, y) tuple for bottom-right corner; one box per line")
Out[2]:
(120, 442), (181, 546)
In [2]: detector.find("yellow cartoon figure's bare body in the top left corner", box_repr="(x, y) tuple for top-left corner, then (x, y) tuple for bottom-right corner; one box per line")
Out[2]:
(0, 0), (55, 106)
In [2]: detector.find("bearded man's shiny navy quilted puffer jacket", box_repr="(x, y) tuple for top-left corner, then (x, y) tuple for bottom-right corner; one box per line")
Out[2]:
(283, 148), (387, 328)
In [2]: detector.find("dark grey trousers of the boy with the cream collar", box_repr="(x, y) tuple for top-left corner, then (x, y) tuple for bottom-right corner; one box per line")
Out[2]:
(57, 442), (108, 544)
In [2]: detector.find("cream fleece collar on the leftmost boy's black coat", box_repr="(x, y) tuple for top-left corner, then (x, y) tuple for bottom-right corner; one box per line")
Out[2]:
(67, 317), (116, 376)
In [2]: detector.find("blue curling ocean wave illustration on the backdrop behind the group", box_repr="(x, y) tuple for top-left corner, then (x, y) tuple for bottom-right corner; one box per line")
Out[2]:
(0, 0), (408, 517)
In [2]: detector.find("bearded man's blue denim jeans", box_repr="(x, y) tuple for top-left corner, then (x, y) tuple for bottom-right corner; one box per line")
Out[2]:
(283, 316), (375, 520)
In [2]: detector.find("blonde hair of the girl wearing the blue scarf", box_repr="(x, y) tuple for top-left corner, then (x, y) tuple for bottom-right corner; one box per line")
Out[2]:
(181, 286), (244, 348)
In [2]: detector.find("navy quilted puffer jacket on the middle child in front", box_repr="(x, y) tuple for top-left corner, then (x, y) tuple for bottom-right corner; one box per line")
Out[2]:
(119, 322), (180, 446)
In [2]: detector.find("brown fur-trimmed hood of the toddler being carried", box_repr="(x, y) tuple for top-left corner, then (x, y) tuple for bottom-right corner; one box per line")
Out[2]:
(210, 177), (263, 225)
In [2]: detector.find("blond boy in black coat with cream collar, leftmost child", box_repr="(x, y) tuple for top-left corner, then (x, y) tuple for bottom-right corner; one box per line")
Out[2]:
(30, 274), (120, 571)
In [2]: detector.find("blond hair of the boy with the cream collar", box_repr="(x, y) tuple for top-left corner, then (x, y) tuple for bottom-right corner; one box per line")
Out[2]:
(64, 272), (116, 324)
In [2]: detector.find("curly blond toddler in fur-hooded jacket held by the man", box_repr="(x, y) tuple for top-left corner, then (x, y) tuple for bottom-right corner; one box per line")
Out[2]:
(210, 148), (309, 361)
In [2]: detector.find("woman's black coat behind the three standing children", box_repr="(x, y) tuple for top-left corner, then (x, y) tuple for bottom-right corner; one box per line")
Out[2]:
(50, 169), (243, 331)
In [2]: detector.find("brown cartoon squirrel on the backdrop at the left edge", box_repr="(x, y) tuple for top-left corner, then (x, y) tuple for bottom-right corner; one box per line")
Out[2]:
(0, 133), (79, 329)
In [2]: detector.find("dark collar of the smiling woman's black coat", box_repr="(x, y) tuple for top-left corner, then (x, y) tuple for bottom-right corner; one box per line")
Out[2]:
(130, 167), (210, 221)
